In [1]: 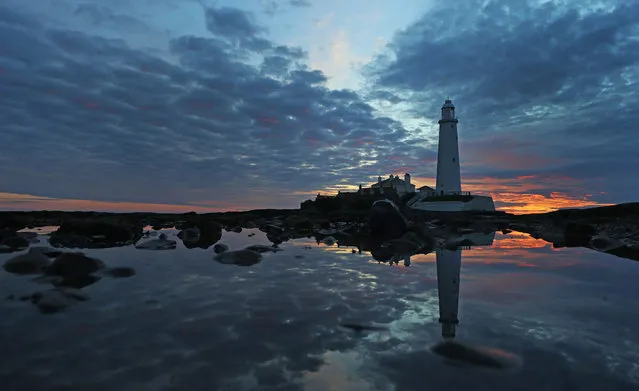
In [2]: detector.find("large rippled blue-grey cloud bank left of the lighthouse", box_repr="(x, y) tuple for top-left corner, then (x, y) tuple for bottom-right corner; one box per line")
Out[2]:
(0, 3), (420, 207)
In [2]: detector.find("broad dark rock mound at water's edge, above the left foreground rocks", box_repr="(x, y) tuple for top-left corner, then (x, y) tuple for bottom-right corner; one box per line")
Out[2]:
(49, 220), (142, 248)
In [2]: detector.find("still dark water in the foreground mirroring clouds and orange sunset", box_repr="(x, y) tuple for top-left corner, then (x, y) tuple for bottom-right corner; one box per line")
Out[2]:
(0, 230), (639, 391)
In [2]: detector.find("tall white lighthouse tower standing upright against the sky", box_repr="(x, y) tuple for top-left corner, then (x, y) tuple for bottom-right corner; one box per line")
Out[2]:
(435, 98), (461, 195)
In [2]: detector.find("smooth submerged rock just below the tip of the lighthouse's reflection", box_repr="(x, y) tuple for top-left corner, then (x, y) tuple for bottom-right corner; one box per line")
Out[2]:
(431, 340), (520, 369)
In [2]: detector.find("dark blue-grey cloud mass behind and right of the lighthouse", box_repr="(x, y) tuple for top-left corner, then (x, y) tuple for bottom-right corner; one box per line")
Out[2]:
(367, 0), (639, 202)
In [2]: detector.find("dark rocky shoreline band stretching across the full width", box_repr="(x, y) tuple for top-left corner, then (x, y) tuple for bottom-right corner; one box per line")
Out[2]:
(0, 203), (639, 260)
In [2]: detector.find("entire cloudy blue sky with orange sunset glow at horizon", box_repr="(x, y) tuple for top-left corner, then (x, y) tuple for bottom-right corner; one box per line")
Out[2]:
(0, 0), (639, 212)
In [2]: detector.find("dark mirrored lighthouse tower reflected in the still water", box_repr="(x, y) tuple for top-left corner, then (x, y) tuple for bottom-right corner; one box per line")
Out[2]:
(436, 248), (462, 338)
